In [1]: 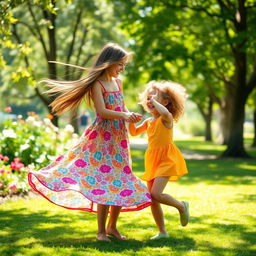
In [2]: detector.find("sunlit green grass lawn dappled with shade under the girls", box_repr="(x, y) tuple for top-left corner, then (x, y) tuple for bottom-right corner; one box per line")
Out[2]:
(0, 141), (256, 256)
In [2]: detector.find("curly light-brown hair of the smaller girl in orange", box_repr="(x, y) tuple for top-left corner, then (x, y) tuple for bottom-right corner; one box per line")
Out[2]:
(139, 81), (187, 121)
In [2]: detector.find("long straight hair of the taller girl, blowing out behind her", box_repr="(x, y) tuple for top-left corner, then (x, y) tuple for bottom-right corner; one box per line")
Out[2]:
(40, 43), (132, 115)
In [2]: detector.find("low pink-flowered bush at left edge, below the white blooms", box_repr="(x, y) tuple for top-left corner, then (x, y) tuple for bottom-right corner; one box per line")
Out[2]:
(0, 154), (29, 196)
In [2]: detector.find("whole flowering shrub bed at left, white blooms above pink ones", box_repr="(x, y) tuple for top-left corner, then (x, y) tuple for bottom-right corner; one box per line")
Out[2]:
(0, 108), (77, 196)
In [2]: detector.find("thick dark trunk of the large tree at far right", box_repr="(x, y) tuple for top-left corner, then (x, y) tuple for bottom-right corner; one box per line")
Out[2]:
(213, 0), (256, 157)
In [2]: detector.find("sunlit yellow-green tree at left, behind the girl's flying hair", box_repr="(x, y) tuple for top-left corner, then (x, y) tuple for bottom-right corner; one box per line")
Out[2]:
(2, 0), (121, 130)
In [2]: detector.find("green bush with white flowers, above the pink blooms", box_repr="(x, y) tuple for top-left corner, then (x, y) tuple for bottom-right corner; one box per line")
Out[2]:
(0, 114), (77, 169)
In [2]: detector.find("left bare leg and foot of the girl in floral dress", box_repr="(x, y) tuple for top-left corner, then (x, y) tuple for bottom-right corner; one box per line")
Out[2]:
(97, 204), (111, 242)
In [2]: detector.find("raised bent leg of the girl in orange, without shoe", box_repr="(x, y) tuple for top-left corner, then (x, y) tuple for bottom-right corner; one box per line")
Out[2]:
(151, 177), (185, 213)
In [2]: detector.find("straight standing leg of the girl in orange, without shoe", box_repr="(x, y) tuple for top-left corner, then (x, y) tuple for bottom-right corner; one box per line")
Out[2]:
(147, 181), (166, 234)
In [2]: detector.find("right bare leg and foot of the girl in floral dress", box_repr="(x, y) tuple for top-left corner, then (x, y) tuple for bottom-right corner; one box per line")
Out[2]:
(107, 206), (127, 240)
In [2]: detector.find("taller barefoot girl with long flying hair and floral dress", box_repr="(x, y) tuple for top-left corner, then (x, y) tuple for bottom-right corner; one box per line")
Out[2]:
(28, 43), (151, 241)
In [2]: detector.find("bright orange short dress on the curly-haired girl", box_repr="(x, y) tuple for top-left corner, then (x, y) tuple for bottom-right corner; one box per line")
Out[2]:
(130, 117), (188, 181)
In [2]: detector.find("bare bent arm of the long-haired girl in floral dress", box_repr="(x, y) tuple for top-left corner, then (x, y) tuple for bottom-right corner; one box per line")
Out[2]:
(92, 82), (138, 122)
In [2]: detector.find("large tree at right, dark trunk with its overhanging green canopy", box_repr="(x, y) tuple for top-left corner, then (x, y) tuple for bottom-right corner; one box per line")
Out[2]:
(111, 0), (256, 157)
